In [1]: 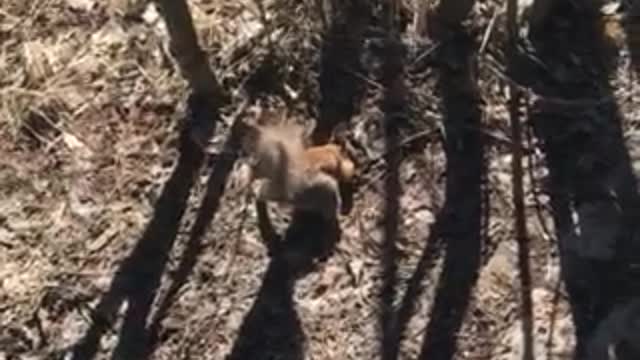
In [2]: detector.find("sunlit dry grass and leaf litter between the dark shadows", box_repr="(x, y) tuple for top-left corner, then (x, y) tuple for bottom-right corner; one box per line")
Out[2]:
(0, 0), (639, 359)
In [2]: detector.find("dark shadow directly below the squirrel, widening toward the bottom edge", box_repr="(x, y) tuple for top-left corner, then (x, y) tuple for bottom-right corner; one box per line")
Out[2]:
(226, 201), (340, 360)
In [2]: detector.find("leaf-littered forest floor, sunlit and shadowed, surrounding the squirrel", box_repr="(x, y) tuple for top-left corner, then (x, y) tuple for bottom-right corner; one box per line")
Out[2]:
(0, 0), (640, 360)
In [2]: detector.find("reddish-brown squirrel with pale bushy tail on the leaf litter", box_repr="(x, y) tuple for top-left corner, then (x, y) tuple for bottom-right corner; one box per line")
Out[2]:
(243, 119), (355, 219)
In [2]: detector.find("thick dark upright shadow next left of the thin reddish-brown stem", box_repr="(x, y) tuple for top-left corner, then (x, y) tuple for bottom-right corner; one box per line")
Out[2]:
(419, 29), (486, 360)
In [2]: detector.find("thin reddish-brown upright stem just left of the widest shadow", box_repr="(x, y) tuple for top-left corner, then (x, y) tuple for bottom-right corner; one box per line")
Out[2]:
(506, 0), (533, 360)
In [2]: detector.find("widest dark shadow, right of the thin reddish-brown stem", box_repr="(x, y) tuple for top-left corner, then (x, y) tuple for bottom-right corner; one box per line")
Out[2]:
(513, 0), (640, 359)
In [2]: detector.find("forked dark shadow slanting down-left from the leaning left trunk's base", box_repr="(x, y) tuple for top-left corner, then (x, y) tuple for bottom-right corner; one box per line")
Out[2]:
(67, 94), (235, 360)
